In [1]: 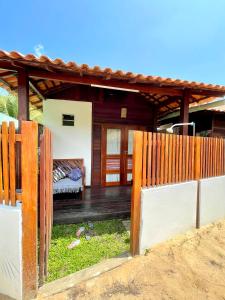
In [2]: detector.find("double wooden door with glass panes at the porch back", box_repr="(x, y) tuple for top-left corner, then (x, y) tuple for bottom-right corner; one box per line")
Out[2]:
(101, 124), (143, 186)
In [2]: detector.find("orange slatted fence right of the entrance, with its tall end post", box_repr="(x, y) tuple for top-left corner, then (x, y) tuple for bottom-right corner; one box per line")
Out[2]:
(131, 131), (225, 255)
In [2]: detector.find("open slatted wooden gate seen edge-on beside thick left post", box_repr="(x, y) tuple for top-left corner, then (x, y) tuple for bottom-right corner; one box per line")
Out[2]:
(39, 127), (53, 285)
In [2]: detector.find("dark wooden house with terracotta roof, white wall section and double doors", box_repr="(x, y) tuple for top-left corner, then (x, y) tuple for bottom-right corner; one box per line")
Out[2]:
(0, 51), (225, 187)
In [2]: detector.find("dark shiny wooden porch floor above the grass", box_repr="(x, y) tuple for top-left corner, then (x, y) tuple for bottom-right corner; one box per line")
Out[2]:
(54, 186), (131, 224)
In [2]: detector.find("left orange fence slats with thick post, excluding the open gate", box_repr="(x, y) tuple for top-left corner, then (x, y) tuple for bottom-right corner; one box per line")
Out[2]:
(0, 121), (38, 299)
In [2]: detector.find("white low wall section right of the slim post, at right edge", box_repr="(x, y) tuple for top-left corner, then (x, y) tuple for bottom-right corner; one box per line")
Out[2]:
(199, 176), (225, 226)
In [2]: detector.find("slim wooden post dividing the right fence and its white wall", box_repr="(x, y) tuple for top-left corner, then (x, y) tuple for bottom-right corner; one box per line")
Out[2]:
(194, 136), (201, 228)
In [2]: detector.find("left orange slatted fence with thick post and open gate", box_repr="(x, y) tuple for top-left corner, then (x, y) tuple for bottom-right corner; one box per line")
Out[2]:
(0, 121), (53, 299)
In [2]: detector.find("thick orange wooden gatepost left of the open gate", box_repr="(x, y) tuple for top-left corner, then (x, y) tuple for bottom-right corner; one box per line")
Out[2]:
(21, 121), (38, 300)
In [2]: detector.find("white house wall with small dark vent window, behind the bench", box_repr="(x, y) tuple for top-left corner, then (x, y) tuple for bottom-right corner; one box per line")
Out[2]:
(43, 100), (92, 185)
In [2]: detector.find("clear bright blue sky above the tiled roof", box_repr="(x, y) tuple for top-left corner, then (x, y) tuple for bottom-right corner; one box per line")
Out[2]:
(0, 0), (225, 84)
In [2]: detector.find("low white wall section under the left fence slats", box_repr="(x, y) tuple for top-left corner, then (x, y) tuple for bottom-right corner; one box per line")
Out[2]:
(0, 205), (22, 299)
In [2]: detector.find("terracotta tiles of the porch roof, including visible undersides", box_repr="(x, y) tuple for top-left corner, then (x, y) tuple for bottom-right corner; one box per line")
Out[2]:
(0, 50), (225, 113)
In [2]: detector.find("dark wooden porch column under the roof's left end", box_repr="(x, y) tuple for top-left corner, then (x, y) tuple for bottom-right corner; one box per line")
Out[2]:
(18, 69), (30, 121)
